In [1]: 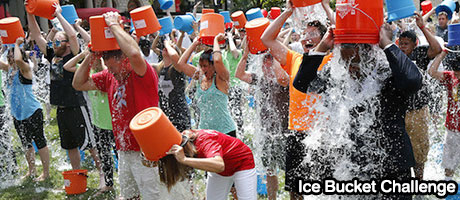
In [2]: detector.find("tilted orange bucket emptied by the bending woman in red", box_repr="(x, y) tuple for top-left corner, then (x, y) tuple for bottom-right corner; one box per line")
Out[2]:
(129, 107), (182, 161)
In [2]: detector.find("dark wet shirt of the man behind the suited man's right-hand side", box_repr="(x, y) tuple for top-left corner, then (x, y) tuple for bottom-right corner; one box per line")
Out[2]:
(408, 46), (431, 110)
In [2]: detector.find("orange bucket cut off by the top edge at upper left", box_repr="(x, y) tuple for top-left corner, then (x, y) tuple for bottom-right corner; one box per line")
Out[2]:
(26, 0), (59, 20)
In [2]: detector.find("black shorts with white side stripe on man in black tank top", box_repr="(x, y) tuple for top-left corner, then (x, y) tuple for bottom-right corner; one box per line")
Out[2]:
(57, 106), (95, 150)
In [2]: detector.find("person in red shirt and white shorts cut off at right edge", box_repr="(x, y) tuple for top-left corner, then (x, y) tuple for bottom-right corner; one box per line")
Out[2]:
(428, 49), (460, 180)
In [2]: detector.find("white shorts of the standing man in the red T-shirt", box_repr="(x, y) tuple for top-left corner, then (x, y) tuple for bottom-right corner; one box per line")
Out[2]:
(118, 151), (160, 199)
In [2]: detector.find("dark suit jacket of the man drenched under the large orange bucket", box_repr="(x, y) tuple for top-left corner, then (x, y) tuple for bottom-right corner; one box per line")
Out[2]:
(293, 44), (422, 178)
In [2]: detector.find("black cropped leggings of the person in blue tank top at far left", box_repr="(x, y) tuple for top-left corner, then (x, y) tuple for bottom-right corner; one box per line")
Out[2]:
(13, 109), (46, 149)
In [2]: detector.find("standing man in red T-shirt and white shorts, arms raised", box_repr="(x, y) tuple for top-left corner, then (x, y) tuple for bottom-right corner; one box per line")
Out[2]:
(72, 12), (160, 199)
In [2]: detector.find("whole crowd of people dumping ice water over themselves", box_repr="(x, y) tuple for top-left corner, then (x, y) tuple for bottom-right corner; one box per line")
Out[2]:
(0, 0), (460, 199)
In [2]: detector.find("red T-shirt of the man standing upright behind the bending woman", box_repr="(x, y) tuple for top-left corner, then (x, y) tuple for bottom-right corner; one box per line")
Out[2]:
(91, 58), (159, 151)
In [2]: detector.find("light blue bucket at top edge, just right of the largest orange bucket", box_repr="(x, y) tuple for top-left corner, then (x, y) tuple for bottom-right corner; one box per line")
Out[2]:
(385, 0), (417, 22)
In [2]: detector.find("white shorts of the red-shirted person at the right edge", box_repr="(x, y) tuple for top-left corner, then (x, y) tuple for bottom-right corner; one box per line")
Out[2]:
(441, 130), (460, 170)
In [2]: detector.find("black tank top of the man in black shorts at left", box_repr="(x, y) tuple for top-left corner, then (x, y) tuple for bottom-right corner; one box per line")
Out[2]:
(46, 47), (86, 107)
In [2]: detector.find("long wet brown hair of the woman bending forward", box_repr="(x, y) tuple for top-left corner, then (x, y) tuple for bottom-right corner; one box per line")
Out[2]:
(158, 137), (197, 191)
